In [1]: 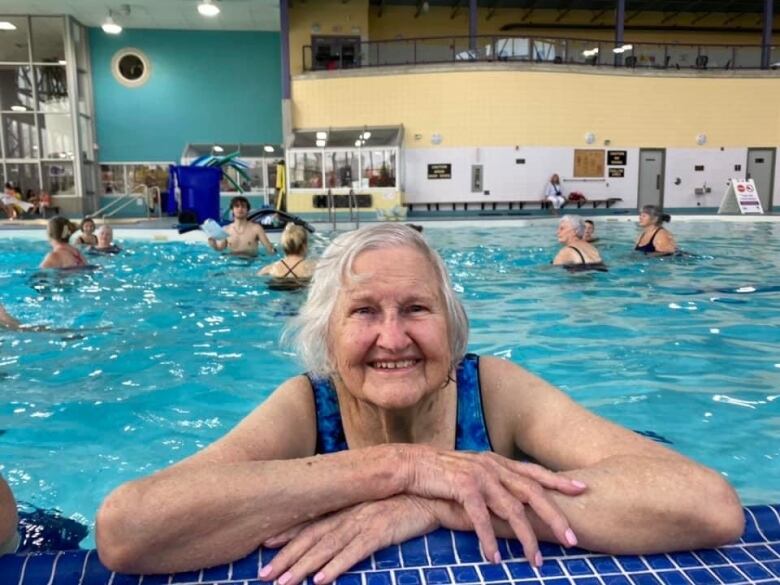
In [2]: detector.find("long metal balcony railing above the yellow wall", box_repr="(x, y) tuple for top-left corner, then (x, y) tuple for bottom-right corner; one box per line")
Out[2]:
(302, 34), (780, 71)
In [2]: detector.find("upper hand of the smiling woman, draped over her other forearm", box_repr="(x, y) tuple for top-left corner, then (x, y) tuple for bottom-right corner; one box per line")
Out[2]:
(405, 445), (586, 566)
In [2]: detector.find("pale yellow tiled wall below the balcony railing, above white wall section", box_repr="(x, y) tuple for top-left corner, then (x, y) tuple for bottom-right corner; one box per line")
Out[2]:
(293, 66), (780, 148)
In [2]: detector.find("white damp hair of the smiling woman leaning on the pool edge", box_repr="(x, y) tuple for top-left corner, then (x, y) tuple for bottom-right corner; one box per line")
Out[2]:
(283, 223), (469, 377)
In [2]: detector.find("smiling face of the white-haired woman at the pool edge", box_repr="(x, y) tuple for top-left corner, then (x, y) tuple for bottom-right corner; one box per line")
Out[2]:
(328, 247), (452, 410)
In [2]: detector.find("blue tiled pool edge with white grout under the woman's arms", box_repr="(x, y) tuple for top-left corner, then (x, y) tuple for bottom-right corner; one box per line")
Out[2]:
(0, 505), (780, 585)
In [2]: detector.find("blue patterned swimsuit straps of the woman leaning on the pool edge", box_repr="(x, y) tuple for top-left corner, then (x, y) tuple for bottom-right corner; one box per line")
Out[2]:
(306, 353), (493, 455)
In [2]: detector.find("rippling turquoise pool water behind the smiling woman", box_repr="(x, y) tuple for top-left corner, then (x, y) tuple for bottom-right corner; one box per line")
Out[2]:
(0, 222), (780, 545)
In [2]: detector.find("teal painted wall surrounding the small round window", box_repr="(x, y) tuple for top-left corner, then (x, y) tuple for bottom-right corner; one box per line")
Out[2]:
(90, 29), (282, 162)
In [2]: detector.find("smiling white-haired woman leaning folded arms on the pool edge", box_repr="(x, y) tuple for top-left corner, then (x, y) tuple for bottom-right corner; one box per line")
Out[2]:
(97, 224), (744, 585)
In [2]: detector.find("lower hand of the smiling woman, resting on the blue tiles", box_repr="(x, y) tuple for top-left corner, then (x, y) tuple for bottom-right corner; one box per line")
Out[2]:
(259, 495), (439, 585)
